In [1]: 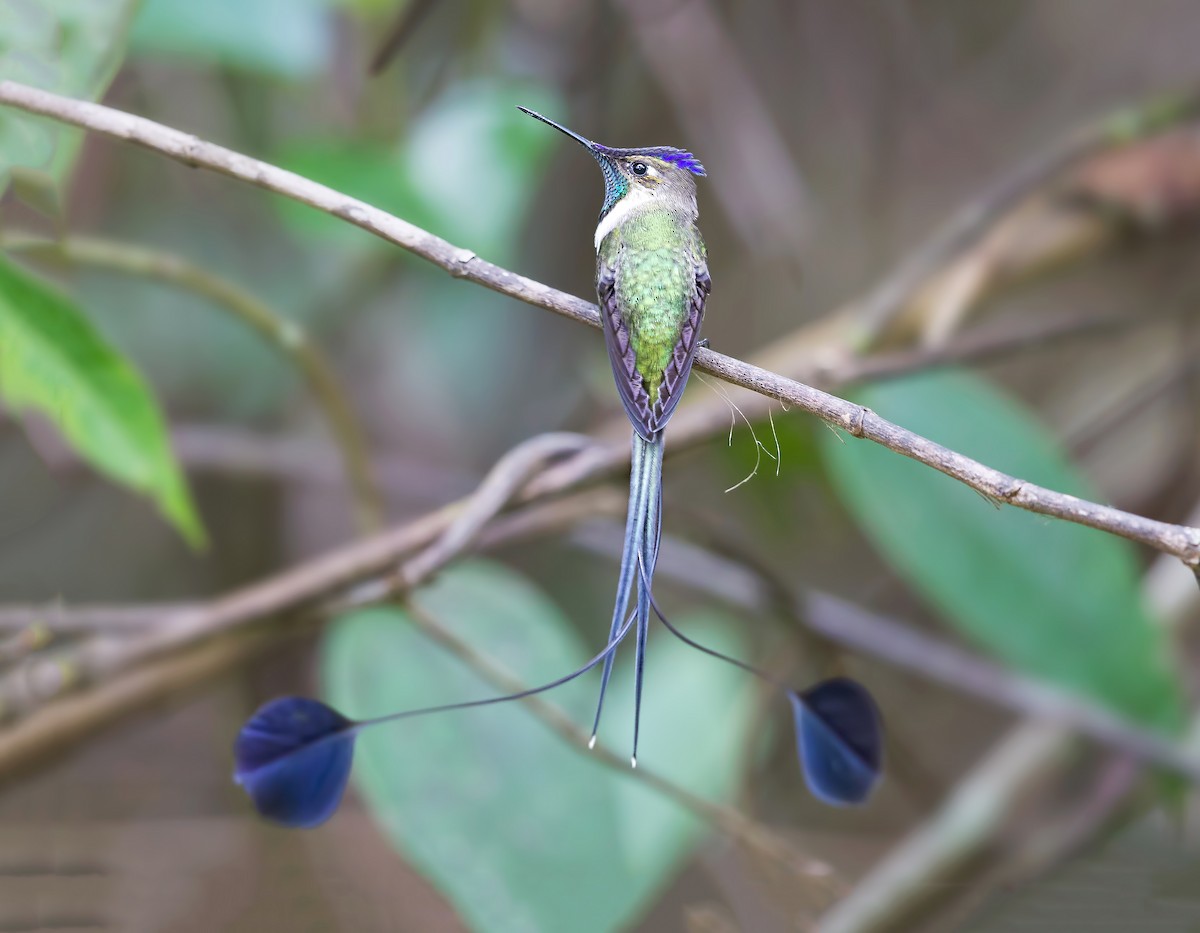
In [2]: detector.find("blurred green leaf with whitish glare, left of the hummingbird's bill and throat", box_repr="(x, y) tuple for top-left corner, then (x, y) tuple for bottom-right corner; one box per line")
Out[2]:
(278, 82), (561, 263)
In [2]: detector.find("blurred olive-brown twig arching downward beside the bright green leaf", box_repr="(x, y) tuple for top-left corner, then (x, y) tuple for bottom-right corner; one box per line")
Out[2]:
(0, 233), (384, 531)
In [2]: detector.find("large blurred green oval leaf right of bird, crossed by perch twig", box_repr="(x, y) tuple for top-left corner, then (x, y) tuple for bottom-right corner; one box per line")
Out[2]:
(821, 373), (1183, 729)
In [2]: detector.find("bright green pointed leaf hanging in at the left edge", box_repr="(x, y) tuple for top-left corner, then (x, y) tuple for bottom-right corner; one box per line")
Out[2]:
(0, 258), (204, 546)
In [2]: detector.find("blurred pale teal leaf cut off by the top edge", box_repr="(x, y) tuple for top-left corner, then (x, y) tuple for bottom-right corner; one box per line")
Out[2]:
(131, 0), (334, 79)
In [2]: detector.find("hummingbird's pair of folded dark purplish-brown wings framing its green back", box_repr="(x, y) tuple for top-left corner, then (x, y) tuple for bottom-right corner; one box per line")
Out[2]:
(596, 258), (713, 440)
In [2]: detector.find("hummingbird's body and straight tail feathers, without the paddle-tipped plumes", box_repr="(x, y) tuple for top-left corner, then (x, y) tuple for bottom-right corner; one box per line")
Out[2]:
(518, 107), (713, 768)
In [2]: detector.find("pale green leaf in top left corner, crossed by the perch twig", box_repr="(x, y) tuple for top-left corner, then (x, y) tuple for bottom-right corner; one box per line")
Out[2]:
(0, 0), (137, 210)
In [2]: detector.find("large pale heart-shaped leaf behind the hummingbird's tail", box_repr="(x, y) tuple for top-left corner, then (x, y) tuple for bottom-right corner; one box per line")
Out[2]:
(322, 562), (752, 933)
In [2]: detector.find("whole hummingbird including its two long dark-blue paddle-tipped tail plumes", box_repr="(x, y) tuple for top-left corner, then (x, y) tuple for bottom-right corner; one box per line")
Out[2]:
(234, 107), (883, 827)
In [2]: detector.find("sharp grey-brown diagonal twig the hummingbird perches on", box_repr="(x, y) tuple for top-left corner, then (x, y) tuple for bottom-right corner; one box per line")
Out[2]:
(0, 80), (1200, 567)
